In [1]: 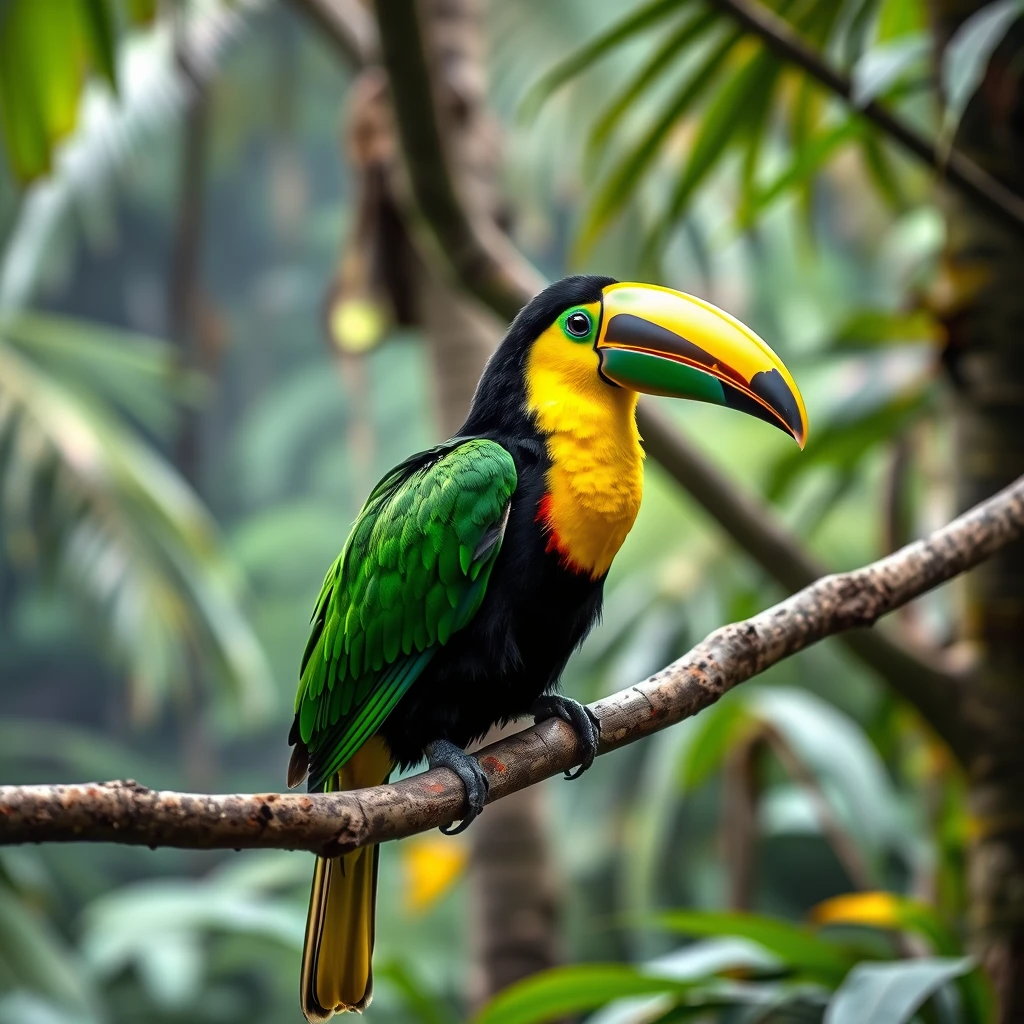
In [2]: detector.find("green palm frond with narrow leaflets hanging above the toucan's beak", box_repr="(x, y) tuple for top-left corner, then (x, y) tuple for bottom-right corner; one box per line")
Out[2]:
(524, 0), (923, 254)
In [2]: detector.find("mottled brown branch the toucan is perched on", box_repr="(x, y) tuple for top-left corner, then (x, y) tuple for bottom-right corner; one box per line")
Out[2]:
(0, 477), (1024, 856)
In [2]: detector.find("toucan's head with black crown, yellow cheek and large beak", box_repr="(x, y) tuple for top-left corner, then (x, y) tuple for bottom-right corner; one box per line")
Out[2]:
(462, 276), (807, 446)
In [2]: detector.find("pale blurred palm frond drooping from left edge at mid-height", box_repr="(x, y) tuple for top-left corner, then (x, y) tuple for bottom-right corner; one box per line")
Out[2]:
(0, 339), (273, 719)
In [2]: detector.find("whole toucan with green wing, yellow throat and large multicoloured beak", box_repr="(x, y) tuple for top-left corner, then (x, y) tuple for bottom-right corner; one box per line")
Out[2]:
(289, 276), (807, 1021)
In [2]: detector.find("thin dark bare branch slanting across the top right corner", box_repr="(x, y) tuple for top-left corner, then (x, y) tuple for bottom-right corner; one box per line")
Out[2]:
(712, 0), (1024, 231)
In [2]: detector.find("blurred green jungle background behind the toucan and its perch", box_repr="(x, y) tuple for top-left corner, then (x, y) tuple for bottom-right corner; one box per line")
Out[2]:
(0, 0), (1024, 1024)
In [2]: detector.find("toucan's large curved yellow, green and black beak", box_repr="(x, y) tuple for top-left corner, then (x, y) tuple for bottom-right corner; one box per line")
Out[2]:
(595, 283), (807, 447)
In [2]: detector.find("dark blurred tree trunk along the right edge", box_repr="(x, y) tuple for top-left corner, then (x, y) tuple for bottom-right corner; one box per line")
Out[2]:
(931, 6), (1024, 1022)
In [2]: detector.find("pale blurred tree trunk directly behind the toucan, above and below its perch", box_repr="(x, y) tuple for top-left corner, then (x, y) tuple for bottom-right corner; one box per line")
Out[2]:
(417, 0), (560, 1012)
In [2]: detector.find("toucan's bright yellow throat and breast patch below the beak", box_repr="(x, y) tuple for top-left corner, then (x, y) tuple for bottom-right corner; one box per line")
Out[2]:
(526, 304), (643, 579)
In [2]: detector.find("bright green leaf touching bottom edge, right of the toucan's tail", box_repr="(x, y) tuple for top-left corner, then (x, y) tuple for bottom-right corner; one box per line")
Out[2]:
(474, 964), (694, 1024)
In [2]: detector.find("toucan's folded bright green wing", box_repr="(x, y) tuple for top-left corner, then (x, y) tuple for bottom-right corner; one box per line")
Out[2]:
(292, 438), (516, 790)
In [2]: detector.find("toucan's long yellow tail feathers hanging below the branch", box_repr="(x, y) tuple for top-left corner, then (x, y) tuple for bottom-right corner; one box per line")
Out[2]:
(302, 737), (391, 1024)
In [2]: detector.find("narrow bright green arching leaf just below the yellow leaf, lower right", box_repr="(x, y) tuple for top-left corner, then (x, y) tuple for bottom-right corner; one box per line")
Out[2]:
(653, 910), (859, 984)
